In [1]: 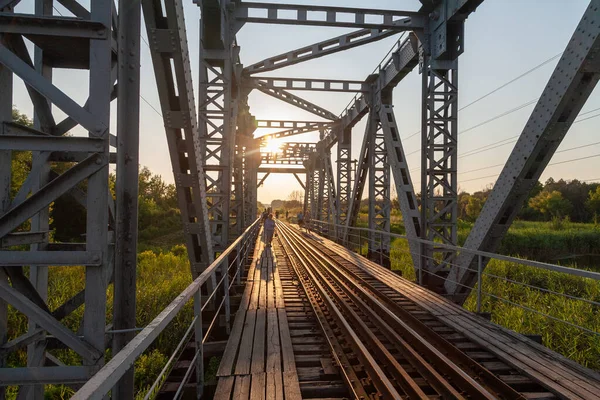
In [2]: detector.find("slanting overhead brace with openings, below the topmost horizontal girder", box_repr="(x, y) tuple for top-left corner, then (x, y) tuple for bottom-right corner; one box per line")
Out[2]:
(244, 23), (398, 74)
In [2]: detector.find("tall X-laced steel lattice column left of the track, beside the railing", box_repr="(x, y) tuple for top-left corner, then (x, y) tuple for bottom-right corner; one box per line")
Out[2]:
(198, 1), (237, 252)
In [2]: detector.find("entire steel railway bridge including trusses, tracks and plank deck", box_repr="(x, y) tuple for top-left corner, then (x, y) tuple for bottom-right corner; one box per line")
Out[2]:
(0, 0), (600, 399)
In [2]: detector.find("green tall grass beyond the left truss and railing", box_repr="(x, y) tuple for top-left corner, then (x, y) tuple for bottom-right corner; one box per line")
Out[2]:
(7, 248), (193, 399)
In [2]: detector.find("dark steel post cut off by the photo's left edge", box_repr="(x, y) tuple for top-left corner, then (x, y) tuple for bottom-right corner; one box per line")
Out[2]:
(0, 14), (13, 400)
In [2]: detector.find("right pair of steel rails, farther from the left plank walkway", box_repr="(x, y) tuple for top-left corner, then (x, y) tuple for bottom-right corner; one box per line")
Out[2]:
(276, 223), (524, 399)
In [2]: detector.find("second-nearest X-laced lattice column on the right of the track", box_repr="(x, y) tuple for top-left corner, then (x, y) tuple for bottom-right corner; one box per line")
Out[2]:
(368, 109), (391, 267)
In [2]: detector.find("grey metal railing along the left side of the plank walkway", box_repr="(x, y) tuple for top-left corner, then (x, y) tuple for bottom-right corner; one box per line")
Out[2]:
(72, 219), (261, 399)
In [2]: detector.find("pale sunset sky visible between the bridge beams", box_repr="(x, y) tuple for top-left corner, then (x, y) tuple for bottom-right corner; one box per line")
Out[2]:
(9, 0), (600, 203)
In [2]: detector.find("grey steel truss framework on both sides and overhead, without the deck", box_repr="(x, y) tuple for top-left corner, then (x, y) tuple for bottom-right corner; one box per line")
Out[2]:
(0, 0), (600, 399)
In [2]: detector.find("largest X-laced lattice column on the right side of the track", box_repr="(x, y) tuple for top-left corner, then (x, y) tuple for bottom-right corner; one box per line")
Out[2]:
(421, 62), (458, 278)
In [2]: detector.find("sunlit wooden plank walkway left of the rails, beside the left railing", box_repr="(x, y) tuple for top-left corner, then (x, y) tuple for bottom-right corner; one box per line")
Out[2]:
(214, 230), (302, 400)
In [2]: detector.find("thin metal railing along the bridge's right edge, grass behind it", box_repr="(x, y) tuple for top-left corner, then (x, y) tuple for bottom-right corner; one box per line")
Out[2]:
(311, 220), (600, 342)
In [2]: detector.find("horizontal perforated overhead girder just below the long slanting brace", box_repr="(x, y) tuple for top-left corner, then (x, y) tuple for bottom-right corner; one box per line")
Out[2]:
(243, 76), (368, 93)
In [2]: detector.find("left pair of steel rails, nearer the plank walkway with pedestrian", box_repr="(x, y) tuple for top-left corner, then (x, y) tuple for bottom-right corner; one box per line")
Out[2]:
(280, 222), (402, 399)
